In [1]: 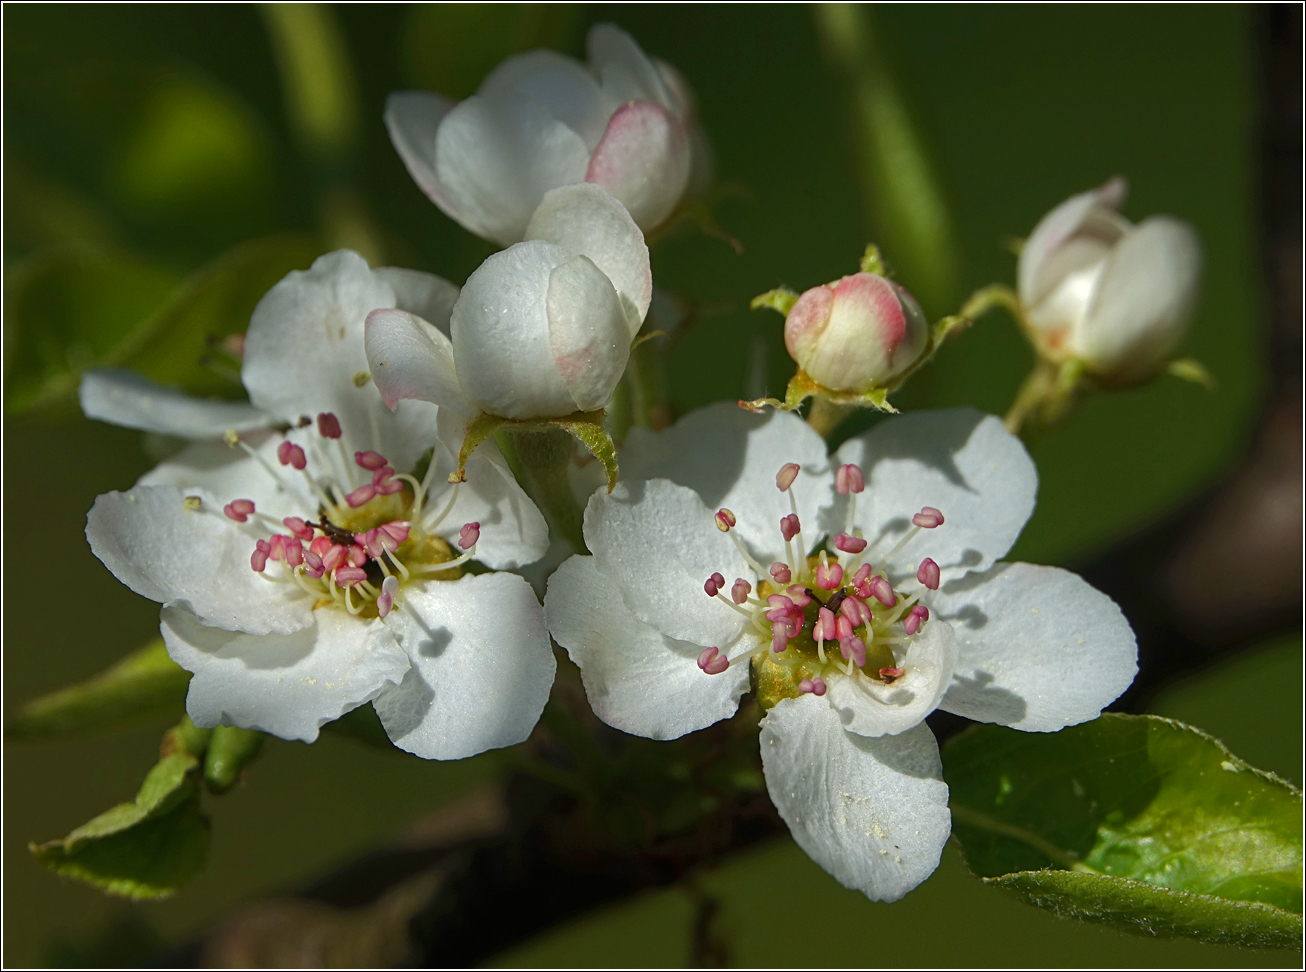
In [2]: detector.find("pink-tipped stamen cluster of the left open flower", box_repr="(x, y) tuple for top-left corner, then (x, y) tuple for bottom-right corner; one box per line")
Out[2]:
(214, 412), (481, 618)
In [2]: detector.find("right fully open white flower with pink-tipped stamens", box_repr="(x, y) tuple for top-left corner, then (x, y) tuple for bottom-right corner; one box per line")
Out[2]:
(545, 405), (1136, 900)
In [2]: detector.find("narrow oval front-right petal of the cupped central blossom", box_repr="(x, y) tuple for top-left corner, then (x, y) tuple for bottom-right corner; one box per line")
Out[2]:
(546, 256), (631, 412)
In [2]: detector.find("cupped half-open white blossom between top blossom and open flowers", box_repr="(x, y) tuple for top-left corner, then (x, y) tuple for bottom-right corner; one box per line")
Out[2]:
(366, 184), (653, 419)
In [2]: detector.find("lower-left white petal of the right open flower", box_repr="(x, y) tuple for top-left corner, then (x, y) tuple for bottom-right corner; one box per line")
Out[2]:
(545, 557), (748, 739)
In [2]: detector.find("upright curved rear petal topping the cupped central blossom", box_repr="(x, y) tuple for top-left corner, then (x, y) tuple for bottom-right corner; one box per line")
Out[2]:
(526, 183), (653, 338)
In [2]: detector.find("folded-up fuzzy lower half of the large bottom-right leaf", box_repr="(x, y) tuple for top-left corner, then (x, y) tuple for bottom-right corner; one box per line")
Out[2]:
(983, 870), (1302, 948)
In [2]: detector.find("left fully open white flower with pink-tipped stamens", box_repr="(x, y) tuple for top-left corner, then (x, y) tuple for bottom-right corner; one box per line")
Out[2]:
(86, 251), (554, 759)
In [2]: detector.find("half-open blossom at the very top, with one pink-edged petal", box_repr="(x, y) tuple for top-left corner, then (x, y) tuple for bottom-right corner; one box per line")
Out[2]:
(385, 24), (707, 246)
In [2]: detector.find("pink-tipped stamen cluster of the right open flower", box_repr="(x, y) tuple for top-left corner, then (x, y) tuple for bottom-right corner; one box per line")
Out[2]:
(699, 462), (943, 695)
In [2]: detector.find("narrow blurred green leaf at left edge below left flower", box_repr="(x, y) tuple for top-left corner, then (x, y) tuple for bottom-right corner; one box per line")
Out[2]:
(5, 639), (191, 739)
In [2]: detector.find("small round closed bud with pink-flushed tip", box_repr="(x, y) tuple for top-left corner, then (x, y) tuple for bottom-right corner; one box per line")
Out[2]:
(785, 273), (929, 393)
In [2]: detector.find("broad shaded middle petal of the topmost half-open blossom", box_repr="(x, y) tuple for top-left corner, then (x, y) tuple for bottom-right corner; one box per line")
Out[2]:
(435, 94), (589, 246)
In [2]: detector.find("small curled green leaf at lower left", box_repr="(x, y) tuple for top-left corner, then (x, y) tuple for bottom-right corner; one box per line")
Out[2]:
(29, 753), (209, 899)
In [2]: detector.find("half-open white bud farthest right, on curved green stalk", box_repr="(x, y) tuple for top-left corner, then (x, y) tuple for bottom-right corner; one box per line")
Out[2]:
(1017, 179), (1202, 384)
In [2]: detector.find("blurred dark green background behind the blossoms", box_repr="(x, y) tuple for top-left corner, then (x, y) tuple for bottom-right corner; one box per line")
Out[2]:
(4, 5), (1301, 967)
